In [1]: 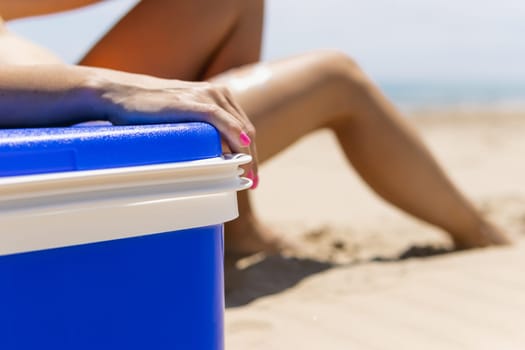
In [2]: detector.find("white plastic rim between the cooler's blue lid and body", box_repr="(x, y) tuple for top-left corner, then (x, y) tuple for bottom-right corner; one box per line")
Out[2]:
(0, 154), (252, 255)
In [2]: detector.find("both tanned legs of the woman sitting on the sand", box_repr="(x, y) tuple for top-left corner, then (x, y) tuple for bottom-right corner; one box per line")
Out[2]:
(81, 0), (504, 251)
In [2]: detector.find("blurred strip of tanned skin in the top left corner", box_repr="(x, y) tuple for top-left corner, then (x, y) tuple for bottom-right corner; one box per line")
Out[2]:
(0, 0), (101, 20)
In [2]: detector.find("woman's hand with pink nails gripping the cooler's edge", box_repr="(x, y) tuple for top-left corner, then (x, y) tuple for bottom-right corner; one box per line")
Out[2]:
(96, 76), (258, 188)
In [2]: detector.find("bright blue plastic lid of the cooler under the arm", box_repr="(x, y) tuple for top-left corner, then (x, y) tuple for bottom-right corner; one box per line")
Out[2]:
(0, 123), (221, 176)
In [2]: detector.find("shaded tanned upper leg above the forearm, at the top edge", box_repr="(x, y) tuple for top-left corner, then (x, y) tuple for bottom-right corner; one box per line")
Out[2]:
(80, 0), (263, 80)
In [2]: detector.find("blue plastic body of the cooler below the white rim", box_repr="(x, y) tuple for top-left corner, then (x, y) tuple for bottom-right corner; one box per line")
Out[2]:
(0, 225), (224, 350)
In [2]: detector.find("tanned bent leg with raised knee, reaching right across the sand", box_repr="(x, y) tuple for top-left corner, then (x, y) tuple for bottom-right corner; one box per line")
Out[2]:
(212, 52), (508, 251)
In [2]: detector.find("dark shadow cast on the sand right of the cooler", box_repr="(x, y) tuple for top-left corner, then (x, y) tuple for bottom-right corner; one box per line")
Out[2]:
(225, 246), (453, 308)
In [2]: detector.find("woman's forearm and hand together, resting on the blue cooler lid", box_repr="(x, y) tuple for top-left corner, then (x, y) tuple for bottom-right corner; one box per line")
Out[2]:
(0, 64), (255, 170)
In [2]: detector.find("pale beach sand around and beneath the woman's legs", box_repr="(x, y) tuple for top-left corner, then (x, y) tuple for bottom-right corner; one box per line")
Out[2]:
(226, 110), (525, 350)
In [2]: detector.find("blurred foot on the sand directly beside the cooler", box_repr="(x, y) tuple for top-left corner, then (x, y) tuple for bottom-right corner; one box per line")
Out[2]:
(224, 214), (290, 256)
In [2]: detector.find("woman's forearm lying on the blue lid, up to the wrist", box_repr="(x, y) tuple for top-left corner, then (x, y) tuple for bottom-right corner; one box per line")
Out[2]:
(0, 64), (106, 128)
